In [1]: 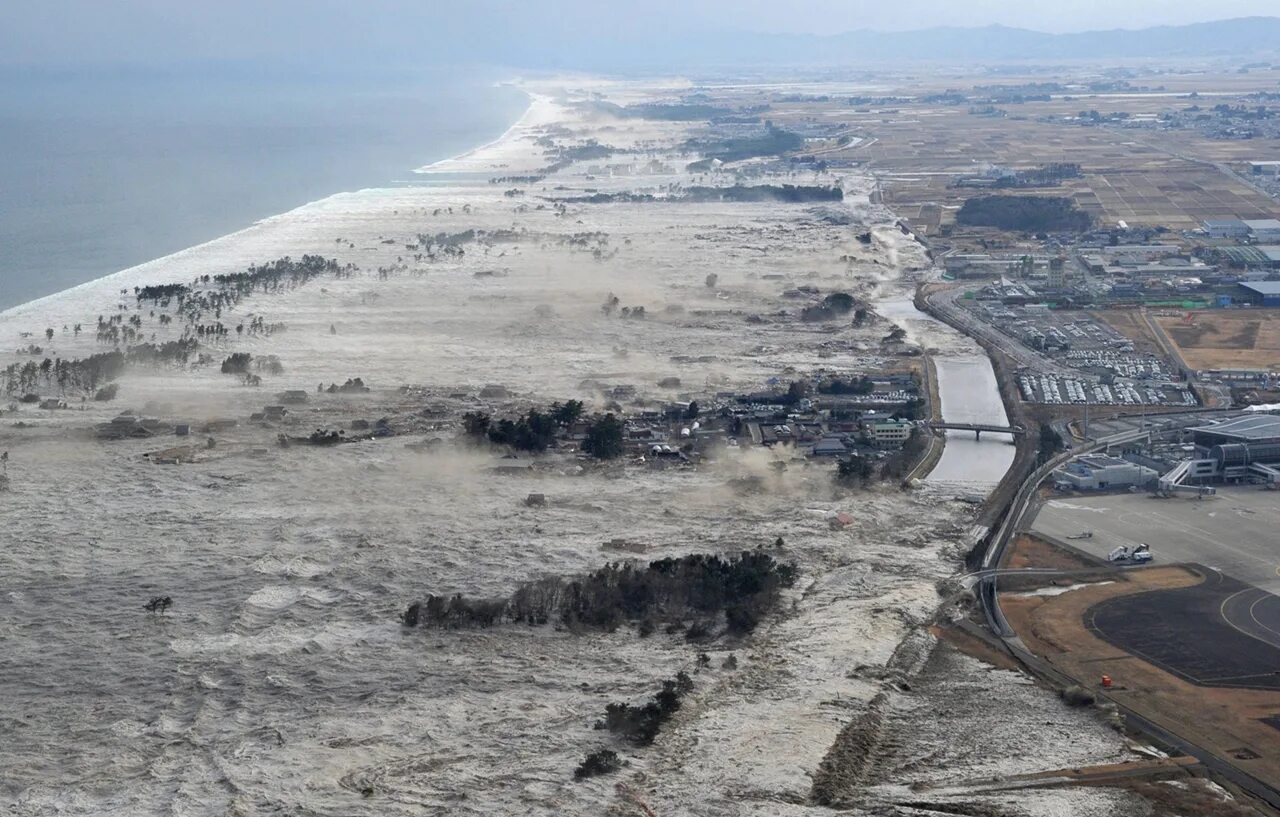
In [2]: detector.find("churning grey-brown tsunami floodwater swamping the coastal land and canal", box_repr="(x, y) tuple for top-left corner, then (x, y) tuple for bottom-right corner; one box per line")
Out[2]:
(0, 81), (1149, 817)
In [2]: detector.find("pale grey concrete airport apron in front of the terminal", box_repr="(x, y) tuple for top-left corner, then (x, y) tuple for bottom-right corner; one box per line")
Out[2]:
(1032, 488), (1280, 594)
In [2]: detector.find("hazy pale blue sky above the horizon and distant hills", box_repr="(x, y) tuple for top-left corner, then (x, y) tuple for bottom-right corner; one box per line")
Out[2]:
(0, 0), (1280, 68)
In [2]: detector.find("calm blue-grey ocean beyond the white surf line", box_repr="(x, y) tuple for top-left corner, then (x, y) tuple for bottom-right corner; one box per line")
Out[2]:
(0, 67), (529, 310)
